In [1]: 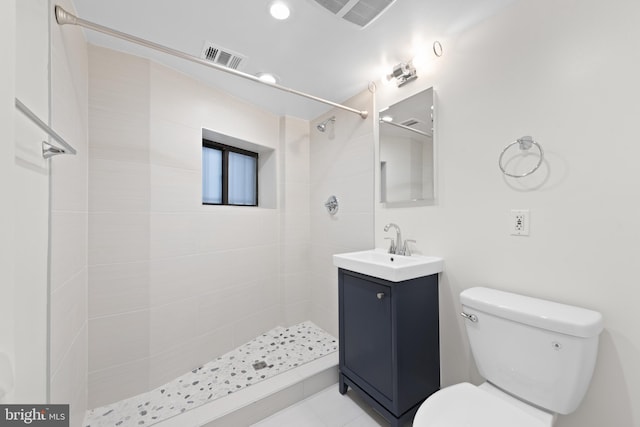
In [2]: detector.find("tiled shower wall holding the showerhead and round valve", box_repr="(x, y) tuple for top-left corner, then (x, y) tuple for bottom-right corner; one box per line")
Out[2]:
(309, 90), (374, 337)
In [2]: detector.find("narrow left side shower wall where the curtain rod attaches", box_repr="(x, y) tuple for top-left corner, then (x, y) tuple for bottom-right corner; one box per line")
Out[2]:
(48, 0), (89, 426)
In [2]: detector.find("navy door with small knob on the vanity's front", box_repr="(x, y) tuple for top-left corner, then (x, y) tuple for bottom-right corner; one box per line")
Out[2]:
(341, 275), (393, 400)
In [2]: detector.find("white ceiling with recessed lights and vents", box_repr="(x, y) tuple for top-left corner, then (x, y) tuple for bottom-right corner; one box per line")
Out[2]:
(74, 0), (517, 120)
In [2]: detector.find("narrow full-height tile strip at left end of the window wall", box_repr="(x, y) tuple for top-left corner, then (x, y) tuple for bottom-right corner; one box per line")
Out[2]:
(88, 46), (150, 408)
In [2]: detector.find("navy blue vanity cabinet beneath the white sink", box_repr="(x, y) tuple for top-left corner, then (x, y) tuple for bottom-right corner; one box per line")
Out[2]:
(338, 268), (440, 427)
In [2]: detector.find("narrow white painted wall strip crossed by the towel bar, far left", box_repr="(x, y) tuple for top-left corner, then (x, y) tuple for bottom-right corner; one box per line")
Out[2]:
(12, 0), (49, 403)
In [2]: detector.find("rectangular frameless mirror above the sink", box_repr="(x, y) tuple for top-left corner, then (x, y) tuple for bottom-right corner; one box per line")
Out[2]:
(378, 88), (435, 207)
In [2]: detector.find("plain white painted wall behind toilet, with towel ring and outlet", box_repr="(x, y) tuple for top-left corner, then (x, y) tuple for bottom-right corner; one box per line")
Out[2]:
(375, 0), (640, 427)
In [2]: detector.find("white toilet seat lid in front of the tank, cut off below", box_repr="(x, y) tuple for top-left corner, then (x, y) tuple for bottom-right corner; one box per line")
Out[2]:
(413, 383), (554, 427)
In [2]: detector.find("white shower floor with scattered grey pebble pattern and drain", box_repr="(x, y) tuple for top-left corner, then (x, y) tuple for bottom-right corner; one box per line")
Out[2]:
(83, 322), (338, 427)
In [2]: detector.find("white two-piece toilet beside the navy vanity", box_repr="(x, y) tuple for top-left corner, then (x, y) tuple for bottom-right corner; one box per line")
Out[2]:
(413, 287), (603, 427)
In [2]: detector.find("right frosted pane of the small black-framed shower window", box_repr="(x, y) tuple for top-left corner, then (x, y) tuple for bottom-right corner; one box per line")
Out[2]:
(229, 151), (257, 206)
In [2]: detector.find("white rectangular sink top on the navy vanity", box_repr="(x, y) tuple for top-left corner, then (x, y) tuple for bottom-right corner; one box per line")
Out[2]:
(333, 249), (444, 282)
